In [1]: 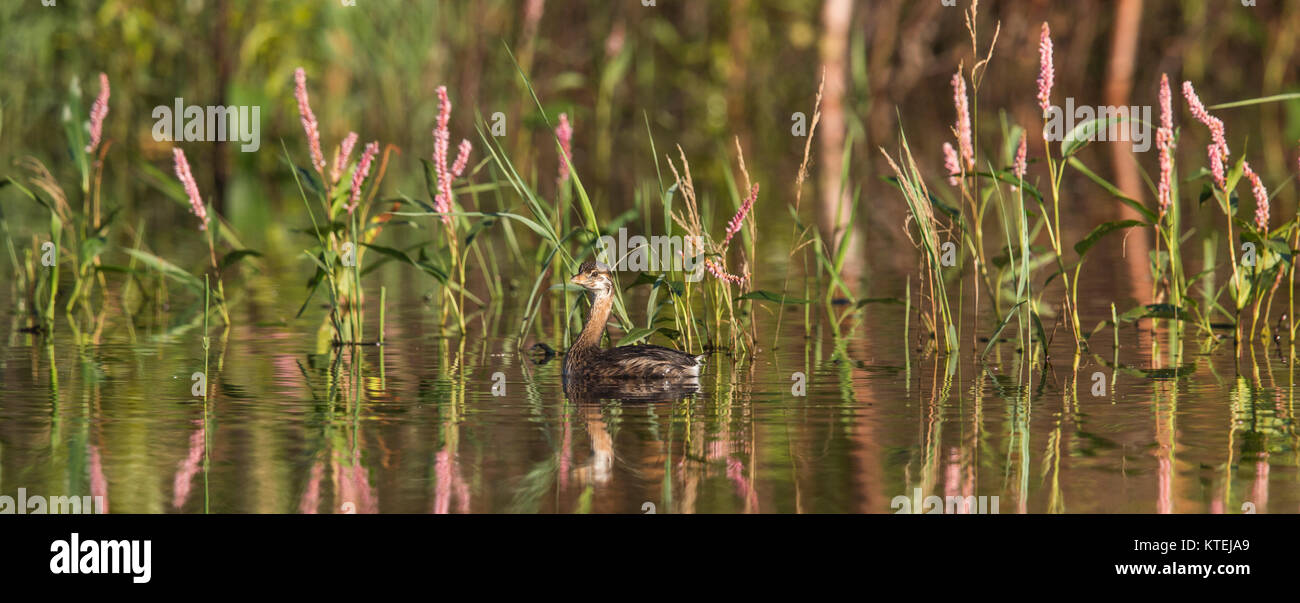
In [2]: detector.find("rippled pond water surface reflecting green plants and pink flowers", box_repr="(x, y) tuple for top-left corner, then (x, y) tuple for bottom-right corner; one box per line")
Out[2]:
(0, 254), (1300, 513)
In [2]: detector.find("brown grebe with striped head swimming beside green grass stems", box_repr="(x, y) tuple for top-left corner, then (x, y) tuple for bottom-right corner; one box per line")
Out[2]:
(564, 260), (703, 381)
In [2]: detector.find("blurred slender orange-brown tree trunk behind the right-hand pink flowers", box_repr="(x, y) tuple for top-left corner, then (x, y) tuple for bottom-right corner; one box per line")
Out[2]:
(1105, 0), (1154, 304)
